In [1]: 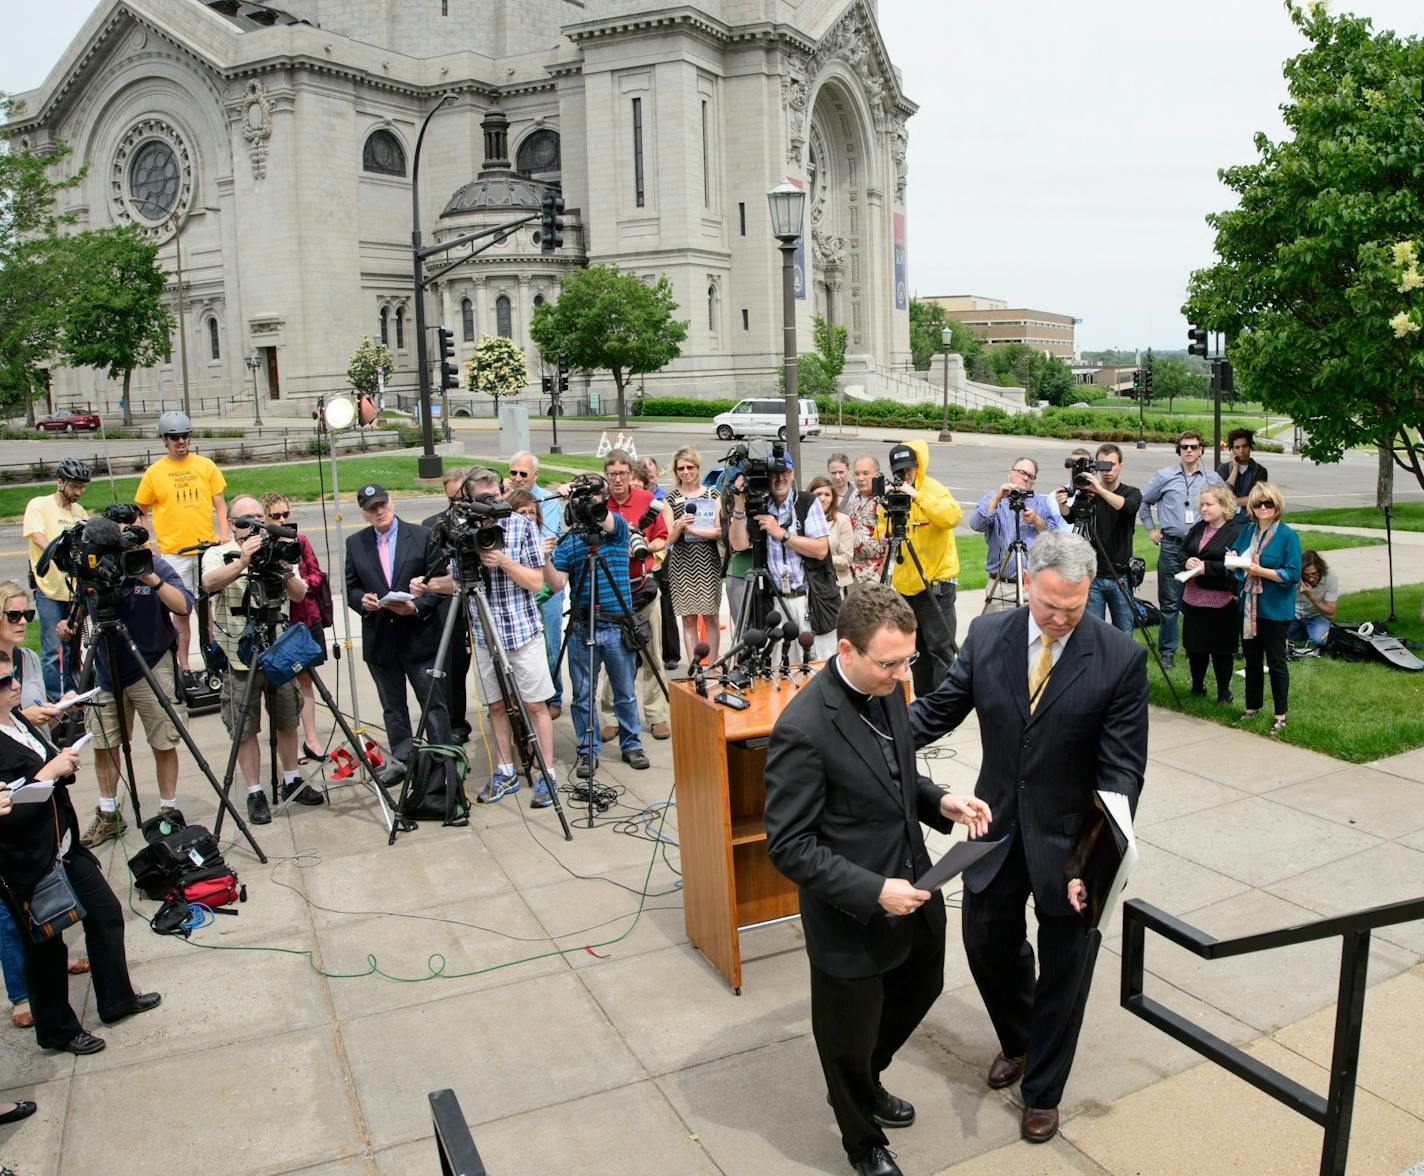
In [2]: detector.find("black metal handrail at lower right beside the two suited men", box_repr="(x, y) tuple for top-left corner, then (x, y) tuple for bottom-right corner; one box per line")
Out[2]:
(1122, 898), (1424, 1176)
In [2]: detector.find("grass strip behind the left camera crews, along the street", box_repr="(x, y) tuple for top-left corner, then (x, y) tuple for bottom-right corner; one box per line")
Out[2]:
(0, 453), (602, 520)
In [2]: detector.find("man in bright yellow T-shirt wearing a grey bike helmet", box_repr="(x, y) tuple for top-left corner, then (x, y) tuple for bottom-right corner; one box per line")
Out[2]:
(134, 411), (231, 673)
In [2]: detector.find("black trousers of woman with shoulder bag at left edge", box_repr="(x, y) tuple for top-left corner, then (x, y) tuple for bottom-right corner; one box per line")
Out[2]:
(0, 846), (134, 1049)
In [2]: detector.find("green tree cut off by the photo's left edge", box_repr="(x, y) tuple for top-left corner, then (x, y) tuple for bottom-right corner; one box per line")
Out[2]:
(0, 94), (83, 426)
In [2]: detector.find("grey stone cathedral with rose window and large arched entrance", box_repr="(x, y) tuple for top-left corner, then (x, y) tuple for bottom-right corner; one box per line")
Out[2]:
(13, 0), (916, 411)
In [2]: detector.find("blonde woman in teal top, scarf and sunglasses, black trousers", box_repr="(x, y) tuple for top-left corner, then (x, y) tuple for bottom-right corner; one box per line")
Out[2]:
(1232, 481), (1300, 735)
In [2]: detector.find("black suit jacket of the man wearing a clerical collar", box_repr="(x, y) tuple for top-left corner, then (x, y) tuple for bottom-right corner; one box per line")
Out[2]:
(766, 661), (953, 978)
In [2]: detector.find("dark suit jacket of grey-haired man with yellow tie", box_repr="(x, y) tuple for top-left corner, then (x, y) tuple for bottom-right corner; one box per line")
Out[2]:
(910, 607), (1148, 917)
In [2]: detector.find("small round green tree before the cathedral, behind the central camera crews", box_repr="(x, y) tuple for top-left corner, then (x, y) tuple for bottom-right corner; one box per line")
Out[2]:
(530, 265), (688, 427)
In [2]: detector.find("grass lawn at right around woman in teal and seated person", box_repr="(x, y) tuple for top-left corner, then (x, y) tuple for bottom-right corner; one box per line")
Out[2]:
(1148, 584), (1424, 763)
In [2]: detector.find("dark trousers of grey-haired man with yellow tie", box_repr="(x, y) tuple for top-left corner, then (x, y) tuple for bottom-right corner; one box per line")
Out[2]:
(963, 837), (1099, 1109)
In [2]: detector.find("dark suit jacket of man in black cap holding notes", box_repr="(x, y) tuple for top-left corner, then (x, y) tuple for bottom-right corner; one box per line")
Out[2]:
(346, 520), (449, 665)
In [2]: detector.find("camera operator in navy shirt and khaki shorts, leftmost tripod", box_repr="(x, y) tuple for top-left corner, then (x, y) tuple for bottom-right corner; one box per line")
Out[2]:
(70, 504), (192, 847)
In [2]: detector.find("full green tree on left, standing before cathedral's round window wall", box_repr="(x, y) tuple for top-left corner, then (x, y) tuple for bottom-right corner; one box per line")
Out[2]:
(61, 225), (174, 424)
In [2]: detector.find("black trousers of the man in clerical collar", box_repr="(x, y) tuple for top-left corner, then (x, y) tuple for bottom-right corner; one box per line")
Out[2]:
(810, 897), (944, 1163)
